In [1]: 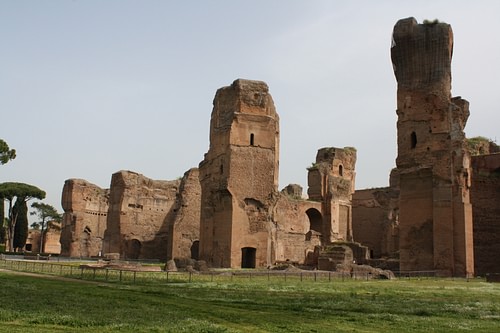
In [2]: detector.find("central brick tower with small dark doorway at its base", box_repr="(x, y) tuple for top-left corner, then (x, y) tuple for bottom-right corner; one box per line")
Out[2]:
(199, 79), (279, 268)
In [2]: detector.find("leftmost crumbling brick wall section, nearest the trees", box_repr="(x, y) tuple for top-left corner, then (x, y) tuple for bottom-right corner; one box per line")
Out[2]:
(60, 179), (109, 258)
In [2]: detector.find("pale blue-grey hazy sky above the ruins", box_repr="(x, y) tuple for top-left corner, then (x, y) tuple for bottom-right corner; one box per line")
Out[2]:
(0, 0), (500, 212)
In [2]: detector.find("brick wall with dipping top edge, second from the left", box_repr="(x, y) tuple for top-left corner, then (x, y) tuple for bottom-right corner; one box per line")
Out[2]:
(104, 171), (180, 260)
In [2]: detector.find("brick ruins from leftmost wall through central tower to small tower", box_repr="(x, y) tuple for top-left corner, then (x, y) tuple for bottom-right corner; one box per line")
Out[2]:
(61, 80), (360, 268)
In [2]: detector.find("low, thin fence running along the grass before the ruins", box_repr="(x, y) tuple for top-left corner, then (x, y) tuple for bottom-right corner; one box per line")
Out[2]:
(0, 259), (435, 283)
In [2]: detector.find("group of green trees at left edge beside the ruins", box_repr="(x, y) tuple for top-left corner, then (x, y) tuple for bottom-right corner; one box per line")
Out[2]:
(0, 139), (61, 252)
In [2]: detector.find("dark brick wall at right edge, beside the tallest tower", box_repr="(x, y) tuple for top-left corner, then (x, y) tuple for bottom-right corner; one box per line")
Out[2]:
(470, 153), (500, 276)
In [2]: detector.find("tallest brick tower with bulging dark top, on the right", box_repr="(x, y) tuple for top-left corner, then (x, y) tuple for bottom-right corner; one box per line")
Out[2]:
(391, 18), (474, 276)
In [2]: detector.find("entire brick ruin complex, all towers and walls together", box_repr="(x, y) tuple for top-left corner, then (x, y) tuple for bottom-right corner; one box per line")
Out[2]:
(61, 18), (500, 276)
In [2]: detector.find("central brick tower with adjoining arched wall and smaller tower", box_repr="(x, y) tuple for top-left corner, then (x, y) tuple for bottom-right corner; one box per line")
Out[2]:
(200, 80), (356, 268)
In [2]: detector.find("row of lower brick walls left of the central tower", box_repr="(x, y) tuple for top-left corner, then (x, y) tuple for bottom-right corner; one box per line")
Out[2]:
(61, 169), (200, 260)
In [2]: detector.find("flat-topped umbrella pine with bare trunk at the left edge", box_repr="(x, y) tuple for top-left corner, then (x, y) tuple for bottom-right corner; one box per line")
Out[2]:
(0, 182), (45, 251)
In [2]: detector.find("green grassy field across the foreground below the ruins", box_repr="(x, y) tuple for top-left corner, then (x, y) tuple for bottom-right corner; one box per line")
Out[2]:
(0, 272), (500, 332)
